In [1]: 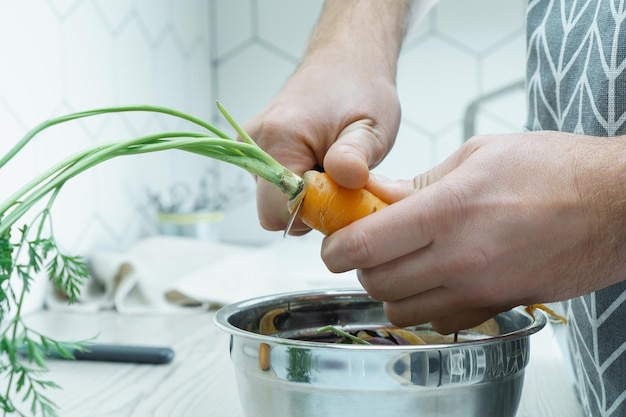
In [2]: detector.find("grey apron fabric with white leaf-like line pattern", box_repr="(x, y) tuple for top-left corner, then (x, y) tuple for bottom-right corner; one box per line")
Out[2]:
(526, 0), (626, 417)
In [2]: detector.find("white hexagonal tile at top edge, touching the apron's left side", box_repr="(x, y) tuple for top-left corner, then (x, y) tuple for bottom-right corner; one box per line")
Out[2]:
(436, 0), (526, 52)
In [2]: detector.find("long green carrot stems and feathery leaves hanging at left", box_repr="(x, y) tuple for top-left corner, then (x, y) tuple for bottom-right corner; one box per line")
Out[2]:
(0, 103), (303, 417)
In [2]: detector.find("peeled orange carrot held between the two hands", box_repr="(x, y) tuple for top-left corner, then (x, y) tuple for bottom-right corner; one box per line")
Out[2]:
(290, 171), (388, 235)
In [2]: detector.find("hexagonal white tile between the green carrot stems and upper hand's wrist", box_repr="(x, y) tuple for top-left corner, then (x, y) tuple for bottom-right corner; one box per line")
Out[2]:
(216, 45), (294, 122)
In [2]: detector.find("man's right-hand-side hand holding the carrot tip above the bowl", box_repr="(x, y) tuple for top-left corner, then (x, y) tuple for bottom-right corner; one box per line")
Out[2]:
(322, 132), (626, 333)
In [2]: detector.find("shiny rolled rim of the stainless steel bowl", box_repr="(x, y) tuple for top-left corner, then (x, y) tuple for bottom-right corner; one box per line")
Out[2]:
(213, 288), (548, 351)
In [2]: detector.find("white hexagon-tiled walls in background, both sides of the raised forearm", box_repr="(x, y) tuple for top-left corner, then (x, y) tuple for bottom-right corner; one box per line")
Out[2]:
(0, 0), (525, 255)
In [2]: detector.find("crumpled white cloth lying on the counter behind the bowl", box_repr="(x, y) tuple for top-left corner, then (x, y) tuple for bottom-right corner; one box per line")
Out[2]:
(46, 236), (360, 314)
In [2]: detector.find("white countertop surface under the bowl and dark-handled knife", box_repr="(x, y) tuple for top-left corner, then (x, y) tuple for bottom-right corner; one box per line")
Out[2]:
(15, 311), (583, 417)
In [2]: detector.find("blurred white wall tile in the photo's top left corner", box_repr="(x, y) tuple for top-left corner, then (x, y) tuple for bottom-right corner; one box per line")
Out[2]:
(0, 0), (62, 127)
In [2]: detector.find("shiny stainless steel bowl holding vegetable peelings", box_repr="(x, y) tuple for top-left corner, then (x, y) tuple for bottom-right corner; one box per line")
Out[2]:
(215, 290), (546, 417)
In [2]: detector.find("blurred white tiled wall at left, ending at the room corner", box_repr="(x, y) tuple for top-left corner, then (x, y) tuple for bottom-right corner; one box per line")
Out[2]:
(0, 0), (213, 254)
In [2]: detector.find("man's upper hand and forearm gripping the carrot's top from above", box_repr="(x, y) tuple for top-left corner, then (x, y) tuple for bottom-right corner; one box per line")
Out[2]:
(243, 0), (410, 234)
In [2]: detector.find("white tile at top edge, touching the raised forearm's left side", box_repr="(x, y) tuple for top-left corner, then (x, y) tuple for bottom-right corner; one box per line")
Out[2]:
(258, 0), (323, 57)
